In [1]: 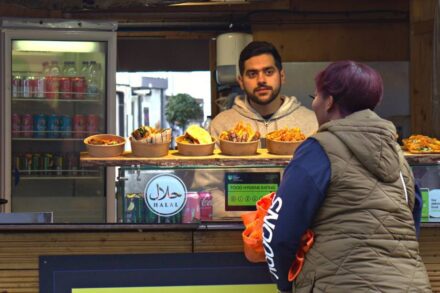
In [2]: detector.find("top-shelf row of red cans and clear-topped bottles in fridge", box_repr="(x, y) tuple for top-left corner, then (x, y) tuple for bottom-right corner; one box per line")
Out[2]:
(12, 61), (101, 99)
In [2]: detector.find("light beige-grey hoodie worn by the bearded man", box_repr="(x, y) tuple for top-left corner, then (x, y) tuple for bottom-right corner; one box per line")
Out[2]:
(210, 96), (318, 138)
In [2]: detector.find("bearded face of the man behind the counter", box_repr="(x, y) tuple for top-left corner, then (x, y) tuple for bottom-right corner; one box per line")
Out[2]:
(238, 54), (285, 105)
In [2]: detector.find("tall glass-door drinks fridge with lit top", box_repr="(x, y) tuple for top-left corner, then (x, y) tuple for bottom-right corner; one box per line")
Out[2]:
(0, 19), (117, 223)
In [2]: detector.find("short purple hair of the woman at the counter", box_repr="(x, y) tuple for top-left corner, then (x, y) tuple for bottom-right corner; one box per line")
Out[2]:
(315, 61), (383, 114)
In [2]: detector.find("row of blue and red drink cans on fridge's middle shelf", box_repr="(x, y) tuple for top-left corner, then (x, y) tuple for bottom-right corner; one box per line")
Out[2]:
(12, 113), (99, 138)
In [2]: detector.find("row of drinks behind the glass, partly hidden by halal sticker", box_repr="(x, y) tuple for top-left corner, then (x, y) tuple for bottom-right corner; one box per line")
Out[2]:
(123, 191), (213, 224)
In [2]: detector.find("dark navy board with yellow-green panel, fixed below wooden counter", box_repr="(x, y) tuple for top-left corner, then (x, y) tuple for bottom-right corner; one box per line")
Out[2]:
(40, 253), (276, 293)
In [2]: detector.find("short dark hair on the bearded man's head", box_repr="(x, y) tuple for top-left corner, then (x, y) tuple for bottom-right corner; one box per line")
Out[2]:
(238, 41), (283, 75)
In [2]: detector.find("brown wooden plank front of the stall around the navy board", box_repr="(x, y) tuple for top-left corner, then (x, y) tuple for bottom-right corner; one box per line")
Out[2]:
(0, 222), (440, 292)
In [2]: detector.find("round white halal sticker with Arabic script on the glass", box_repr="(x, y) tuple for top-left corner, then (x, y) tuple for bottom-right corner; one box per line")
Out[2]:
(144, 174), (186, 217)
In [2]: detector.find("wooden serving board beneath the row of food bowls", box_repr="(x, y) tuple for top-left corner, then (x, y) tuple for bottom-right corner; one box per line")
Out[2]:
(80, 149), (440, 167)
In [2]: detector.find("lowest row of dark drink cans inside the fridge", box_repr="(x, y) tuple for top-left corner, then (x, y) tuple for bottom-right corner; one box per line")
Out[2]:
(12, 152), (81, 176)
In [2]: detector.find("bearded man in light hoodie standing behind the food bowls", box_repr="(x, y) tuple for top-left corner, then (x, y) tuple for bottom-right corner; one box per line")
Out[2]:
(210, 41), (318, 143)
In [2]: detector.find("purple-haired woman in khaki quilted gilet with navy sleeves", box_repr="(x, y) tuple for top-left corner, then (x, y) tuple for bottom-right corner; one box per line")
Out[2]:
(263, 61), (431, 292)
